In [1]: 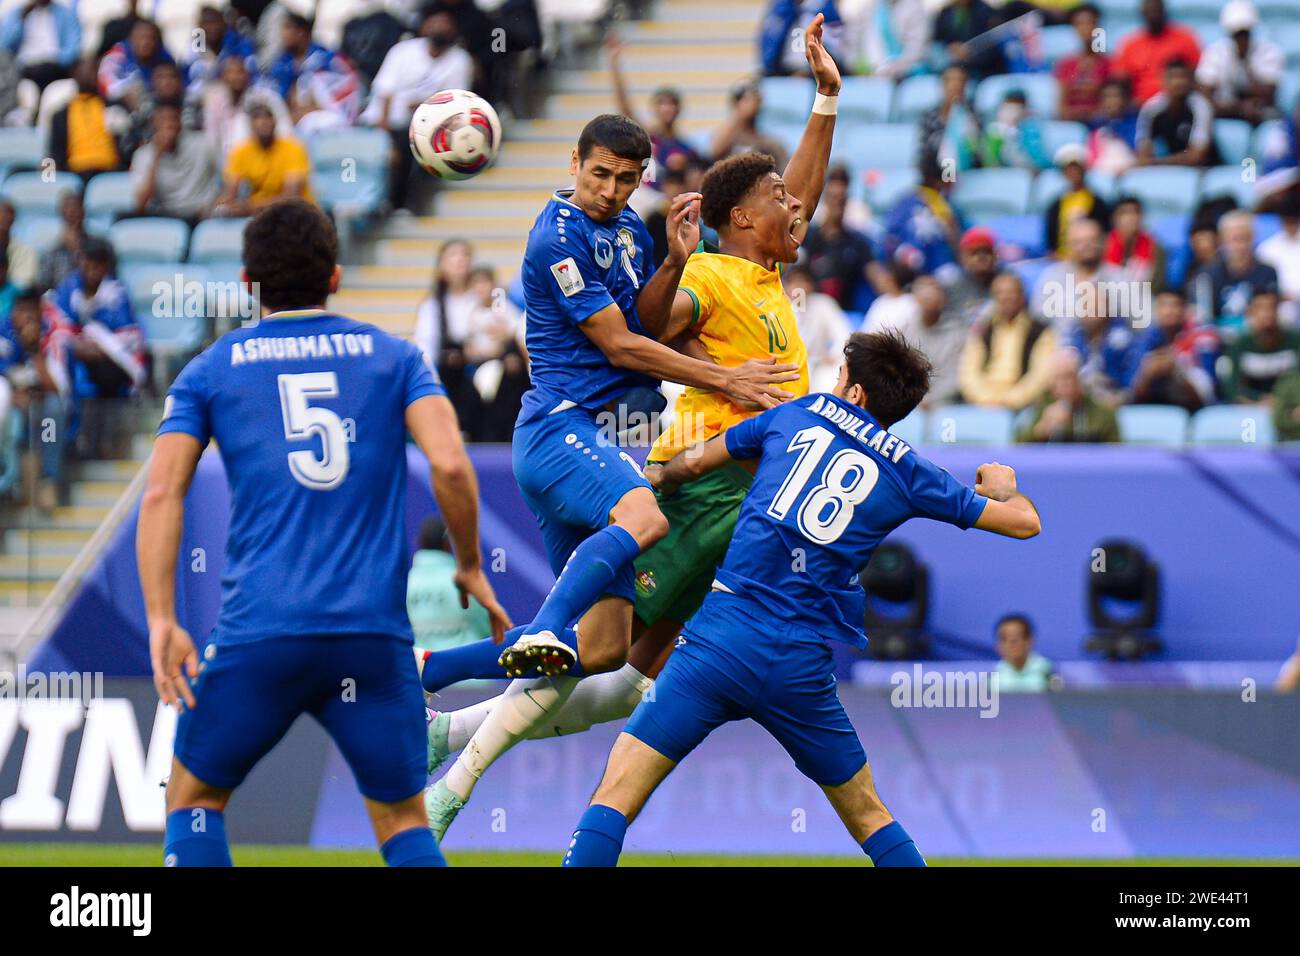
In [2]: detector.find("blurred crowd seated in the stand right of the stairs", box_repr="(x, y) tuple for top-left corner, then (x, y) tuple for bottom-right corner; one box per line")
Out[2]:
(610, 0), (1300, 444)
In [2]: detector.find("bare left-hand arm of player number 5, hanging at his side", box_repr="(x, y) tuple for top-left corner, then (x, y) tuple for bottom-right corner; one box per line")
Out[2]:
(135, 432), (203, 708)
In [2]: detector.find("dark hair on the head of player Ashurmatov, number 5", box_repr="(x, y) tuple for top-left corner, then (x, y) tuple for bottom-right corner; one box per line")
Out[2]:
(243, 199), (338, 310)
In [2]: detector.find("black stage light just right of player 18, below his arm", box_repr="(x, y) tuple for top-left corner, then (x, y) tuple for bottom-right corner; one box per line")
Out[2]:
(858, 542), (930, 661)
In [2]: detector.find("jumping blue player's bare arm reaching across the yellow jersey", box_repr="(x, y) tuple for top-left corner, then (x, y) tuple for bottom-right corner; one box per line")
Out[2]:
(581, 304), (800, 408)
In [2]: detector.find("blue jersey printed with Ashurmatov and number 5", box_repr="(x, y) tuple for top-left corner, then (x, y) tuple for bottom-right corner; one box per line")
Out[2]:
(159, 310), (446, 644)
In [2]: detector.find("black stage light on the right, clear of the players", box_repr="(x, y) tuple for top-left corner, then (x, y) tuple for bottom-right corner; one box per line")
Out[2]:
(1083, 538), (1165, 661)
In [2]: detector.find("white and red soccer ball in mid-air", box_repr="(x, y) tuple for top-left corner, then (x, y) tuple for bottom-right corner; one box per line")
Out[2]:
(411, 90), (501, 179)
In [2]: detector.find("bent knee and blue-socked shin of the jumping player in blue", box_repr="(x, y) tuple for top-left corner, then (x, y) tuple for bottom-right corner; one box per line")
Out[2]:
(524, 486), (668, 637)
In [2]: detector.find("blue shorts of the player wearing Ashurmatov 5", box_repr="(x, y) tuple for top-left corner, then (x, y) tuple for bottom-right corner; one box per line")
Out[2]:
(176, 635), (428, 803)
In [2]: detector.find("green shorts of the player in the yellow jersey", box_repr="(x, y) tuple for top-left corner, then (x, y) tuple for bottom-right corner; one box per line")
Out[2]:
(633, 464), (754, 624)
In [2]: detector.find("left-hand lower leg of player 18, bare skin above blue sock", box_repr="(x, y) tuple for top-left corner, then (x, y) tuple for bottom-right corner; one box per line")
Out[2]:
(560, 734), (677, 866)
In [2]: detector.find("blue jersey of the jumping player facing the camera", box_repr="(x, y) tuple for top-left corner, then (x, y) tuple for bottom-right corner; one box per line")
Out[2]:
(520, 190), (659, 421)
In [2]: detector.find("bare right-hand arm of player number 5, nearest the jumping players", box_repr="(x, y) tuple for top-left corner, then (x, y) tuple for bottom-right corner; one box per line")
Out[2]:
(406, 395), (512, 644)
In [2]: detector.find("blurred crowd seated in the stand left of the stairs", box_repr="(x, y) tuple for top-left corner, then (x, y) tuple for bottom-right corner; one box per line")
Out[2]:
(0, 0), (541, 510)
